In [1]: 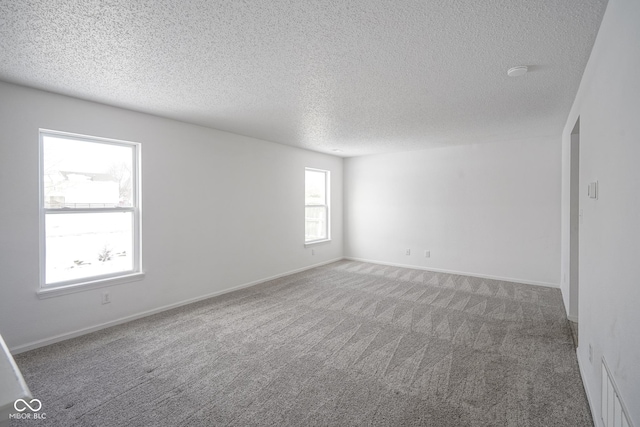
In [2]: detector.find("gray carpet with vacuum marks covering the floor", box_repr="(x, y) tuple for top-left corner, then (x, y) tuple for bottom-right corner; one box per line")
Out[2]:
(12, 261), (593, 427)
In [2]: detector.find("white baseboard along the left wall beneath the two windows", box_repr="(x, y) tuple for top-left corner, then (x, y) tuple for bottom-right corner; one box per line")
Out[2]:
(9, 257), (343, 355)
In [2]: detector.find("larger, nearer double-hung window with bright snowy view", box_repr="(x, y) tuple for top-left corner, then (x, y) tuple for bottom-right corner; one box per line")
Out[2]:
(40, 130), (141, 289)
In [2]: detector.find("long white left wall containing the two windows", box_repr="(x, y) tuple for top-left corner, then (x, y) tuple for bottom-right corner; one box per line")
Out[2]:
(0, 83), (343, 351)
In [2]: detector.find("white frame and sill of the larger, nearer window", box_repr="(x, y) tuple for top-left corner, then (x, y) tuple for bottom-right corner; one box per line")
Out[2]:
(37, 129), (144, 298)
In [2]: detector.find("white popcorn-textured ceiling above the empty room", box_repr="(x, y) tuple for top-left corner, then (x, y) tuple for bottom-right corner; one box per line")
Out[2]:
(0, 0), (606, 156)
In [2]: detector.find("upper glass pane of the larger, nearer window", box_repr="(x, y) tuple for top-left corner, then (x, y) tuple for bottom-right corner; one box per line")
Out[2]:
(42, 135), (134, 208)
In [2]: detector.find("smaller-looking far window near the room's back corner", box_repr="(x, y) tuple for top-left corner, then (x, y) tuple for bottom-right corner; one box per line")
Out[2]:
(304, 168), (330, 243)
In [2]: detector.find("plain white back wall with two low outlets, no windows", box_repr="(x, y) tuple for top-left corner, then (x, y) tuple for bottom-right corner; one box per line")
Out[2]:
(345, 138), (560, 286)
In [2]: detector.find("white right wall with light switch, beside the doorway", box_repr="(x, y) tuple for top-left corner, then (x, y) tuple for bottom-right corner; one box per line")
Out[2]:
(562, 0), (640, 425)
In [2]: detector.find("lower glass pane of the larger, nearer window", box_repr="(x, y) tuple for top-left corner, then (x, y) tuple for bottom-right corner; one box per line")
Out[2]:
(45, 212), (133, 284)
